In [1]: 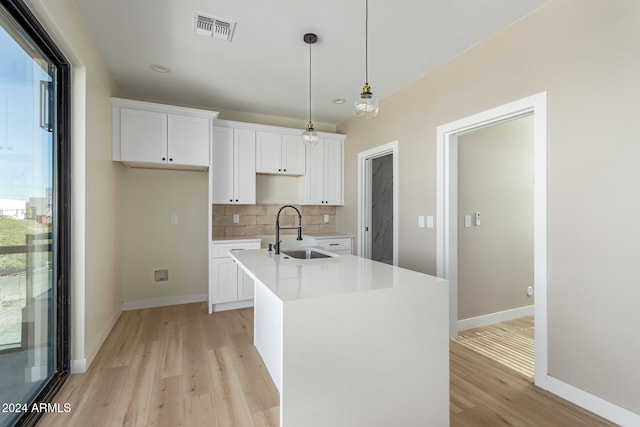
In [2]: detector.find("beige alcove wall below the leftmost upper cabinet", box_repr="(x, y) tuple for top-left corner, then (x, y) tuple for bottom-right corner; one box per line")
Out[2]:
(121, 168), (208, 303)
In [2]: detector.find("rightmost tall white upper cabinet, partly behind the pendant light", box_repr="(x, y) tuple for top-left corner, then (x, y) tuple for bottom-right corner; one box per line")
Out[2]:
(299, 138), (344, 205)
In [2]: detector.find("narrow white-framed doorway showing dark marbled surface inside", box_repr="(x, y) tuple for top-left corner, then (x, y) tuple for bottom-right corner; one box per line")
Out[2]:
(358, 141), (398, 265)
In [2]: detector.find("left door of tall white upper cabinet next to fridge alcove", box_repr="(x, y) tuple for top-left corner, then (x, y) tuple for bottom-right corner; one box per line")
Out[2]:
(209, 127), (234, 204)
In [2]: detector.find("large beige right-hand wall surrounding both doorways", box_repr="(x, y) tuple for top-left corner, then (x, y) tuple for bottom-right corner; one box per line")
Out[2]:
(337, 0), (640, 414)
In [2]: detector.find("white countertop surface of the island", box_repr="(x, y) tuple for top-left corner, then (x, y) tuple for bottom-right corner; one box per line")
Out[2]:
(229, 249), (448, 301)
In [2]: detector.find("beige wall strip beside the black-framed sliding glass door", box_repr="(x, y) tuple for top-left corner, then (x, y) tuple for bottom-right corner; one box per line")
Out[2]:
(27, 0), (122, 366)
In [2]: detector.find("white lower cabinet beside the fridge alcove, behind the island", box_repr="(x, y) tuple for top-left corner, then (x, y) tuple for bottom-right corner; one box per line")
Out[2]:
(209, 239), (260, 314)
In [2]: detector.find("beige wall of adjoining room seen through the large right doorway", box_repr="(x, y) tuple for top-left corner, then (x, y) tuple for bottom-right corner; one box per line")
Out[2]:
(458, 116), (533, 319)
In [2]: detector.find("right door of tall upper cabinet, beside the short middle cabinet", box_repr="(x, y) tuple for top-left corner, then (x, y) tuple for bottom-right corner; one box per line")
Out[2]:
(233, 129), (256, 205)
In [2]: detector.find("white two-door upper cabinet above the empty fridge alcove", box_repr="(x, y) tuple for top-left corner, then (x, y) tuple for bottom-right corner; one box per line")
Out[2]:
(112, 98), (218, 170)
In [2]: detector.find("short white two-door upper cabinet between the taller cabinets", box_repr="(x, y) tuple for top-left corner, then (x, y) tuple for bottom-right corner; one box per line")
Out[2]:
(256, 131), (305, 175)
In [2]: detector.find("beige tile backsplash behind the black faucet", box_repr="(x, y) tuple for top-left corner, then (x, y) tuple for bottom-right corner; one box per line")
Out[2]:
(211, 205), (336, 239)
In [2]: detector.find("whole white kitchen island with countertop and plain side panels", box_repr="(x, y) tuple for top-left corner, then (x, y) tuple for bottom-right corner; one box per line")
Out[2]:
(230, 249), (449, 427)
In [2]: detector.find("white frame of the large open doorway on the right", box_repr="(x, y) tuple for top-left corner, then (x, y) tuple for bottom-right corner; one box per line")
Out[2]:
(436, 92), (547, 383)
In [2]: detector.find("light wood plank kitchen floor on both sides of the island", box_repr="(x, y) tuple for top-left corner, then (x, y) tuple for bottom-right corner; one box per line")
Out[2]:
(39, 303), (613, 427)
